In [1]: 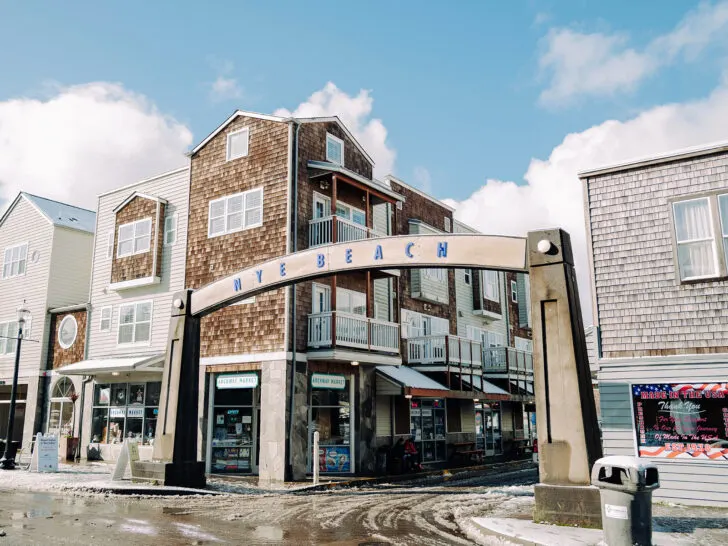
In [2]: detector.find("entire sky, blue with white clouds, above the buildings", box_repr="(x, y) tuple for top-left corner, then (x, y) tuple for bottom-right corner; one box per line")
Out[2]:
(0, 0), (728, 323)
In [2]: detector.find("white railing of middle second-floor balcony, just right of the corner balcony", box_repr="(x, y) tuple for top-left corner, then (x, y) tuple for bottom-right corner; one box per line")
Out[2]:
(407, 335), (483, 368)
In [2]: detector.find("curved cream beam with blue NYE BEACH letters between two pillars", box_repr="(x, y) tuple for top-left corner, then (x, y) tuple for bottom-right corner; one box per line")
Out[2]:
(190, 234), (526, 316)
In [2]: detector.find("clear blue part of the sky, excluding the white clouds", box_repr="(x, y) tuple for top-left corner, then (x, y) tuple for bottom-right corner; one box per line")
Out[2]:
(0, 1), (721, 199)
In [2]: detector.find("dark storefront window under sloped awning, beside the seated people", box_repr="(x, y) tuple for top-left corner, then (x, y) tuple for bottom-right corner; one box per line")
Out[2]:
(410, 398), (447, 463)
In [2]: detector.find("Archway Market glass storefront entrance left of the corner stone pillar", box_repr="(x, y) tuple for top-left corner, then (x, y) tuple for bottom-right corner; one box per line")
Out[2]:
(210, 372), (260, 473)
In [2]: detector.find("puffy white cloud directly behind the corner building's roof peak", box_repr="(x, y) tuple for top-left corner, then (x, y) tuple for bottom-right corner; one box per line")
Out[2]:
(274, 82), (397, 178)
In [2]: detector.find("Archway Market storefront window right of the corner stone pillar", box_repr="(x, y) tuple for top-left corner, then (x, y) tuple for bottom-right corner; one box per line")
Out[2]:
(309, 373), (354, 473)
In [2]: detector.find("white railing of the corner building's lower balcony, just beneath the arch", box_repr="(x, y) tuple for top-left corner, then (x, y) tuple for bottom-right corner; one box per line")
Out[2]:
(308, 311), (399, 353)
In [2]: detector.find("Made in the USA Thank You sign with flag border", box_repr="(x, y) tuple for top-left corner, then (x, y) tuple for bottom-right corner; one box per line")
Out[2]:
(632, 383), (728, 462)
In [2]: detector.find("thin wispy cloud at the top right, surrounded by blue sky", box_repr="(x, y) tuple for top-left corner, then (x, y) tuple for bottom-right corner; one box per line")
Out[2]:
(539, 2), (728, 106)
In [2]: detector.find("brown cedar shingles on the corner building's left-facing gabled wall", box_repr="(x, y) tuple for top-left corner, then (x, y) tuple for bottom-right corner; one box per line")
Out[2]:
(186, 116), (288, 357)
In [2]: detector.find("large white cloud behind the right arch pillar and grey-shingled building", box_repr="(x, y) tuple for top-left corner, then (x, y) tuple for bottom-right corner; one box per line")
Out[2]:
(448, 78), (728, 324)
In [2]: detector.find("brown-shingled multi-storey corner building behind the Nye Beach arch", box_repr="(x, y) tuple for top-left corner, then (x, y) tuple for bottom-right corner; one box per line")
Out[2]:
(185, 111), (533, 480)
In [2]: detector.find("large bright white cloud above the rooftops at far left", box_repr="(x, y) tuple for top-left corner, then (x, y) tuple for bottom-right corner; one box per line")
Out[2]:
(0, 82), (192, 209)
